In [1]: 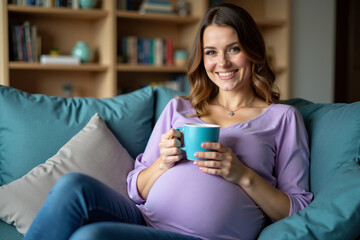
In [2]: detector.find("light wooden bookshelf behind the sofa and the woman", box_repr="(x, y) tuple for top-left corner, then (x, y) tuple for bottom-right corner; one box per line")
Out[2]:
(0, 0), (290, 98)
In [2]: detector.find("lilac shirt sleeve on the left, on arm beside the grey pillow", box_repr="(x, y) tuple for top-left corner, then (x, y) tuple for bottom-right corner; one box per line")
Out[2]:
(127, 100), (176, 204)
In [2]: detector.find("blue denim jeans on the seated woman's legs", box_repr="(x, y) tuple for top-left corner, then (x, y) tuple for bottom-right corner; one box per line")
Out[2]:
(24, 173), (201, 240)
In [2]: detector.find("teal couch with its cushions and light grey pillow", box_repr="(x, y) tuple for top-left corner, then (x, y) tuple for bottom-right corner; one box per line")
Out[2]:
(0, 86), (360, 240)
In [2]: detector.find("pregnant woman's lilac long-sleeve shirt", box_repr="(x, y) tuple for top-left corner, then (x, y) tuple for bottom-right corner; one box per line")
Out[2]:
(127, 98), (312, 240)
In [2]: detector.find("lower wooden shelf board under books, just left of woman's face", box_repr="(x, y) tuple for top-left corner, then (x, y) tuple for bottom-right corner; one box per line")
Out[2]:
(117, 64), (186, 73)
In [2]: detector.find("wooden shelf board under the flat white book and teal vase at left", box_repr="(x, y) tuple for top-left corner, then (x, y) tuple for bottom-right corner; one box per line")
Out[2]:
(9, 62), (108, 72)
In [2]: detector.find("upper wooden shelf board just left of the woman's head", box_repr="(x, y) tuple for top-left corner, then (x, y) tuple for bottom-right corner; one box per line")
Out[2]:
(116, 10), (200, 24)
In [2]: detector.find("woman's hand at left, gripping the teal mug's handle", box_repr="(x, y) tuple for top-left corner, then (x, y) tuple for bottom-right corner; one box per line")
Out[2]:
(159, 128), (182, 170)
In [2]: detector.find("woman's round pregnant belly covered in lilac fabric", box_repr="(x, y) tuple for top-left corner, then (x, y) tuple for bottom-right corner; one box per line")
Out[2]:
(142, 160), (264, 239)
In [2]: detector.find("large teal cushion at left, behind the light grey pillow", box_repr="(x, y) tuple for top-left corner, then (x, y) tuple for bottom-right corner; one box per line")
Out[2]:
(0, 86), (154, 185)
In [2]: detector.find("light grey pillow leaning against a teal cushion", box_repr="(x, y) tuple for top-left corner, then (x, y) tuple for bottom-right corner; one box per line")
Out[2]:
(0, 113), (134, 234)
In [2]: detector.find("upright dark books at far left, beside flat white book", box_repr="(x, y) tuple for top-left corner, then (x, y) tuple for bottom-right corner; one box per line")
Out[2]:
(9, 21), (41, 62)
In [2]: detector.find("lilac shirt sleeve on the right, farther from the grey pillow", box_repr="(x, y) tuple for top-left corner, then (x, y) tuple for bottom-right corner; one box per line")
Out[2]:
(275, 107), (313, 216)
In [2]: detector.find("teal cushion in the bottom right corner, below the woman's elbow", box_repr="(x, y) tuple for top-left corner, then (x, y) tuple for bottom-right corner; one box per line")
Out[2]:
(259, 158), (360, 240)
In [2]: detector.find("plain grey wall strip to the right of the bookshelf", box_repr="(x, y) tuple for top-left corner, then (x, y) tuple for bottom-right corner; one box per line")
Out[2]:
(290, 0), (336, 103)
